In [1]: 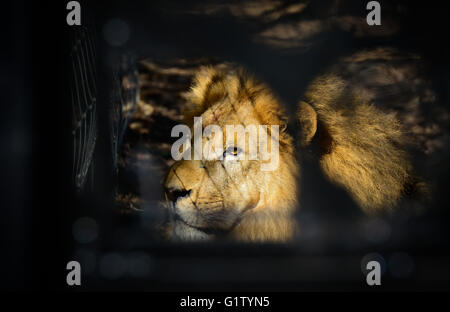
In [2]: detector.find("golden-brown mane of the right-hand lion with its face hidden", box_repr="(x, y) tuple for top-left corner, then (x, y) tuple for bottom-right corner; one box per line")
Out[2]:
(299, 74), (424, 212)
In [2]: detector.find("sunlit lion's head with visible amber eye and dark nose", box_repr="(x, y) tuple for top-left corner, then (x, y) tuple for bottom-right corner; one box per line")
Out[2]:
(165, 67), (298, 241)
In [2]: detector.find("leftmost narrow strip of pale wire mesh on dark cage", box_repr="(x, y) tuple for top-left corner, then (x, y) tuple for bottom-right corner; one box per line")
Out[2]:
(71, 26), (97, 191)
